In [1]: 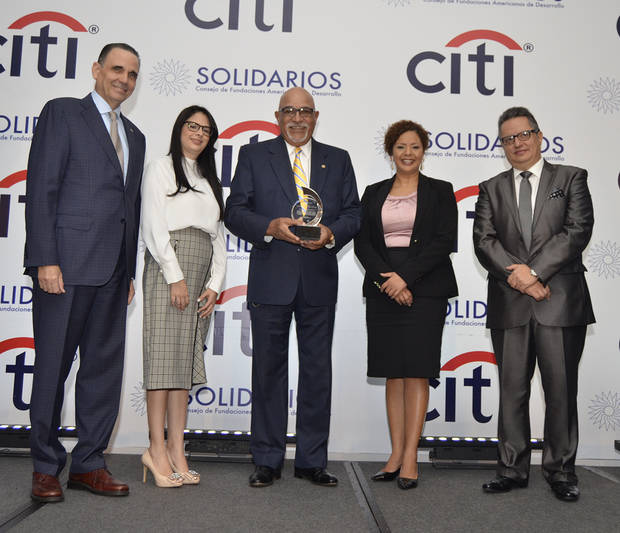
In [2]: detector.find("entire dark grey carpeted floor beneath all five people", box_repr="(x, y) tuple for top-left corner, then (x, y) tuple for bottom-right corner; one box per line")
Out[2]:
(0, 455), (620, 533)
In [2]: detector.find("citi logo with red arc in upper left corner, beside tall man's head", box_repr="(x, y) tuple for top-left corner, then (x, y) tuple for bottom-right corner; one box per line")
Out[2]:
(0, 11), (88, 79)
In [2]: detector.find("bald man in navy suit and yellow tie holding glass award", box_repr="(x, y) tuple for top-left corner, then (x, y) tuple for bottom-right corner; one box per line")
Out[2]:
(225, 87), (361, 487)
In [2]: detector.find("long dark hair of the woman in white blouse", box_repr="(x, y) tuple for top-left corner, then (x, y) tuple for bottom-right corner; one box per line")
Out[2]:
(168, 105), (224, 220)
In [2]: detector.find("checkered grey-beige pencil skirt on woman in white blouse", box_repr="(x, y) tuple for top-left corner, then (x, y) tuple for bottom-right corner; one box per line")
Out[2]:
(142, 228), (213, 390)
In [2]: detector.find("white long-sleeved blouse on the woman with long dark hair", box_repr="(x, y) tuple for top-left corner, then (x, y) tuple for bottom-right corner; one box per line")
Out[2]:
(140, 156), (226, 294)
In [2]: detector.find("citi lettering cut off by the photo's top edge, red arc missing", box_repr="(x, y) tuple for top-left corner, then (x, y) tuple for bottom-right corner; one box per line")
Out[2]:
(185, 0), (293, 33)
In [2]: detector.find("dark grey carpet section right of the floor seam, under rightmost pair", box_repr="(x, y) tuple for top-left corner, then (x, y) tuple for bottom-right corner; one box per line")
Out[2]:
(360, 463), (620, 533)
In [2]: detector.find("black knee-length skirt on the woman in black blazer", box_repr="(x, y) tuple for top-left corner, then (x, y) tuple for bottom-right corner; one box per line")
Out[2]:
(366, 248), (448, 378)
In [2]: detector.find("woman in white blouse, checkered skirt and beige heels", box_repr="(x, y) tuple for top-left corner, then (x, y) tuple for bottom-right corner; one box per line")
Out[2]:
(141, 106), (226, 487)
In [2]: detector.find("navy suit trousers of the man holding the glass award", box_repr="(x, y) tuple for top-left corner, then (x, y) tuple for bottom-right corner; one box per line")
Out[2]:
(248, 280), (335, 469)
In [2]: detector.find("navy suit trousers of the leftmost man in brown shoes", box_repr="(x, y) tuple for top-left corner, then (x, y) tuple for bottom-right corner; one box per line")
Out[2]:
(30, 246), (129, 476)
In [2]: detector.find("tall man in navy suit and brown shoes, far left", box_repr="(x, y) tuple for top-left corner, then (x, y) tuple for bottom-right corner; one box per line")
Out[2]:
(24, 43), (145, 502)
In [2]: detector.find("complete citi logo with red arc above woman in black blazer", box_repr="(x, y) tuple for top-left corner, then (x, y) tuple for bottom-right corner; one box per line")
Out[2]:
(407, 30), (523, 96)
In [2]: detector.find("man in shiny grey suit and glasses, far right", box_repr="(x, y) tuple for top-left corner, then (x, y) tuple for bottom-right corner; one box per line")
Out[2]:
(474, 107), (594, 501)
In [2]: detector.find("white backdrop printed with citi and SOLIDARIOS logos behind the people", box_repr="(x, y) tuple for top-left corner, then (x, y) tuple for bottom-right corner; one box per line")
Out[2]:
(0, 0), (620, 459)
